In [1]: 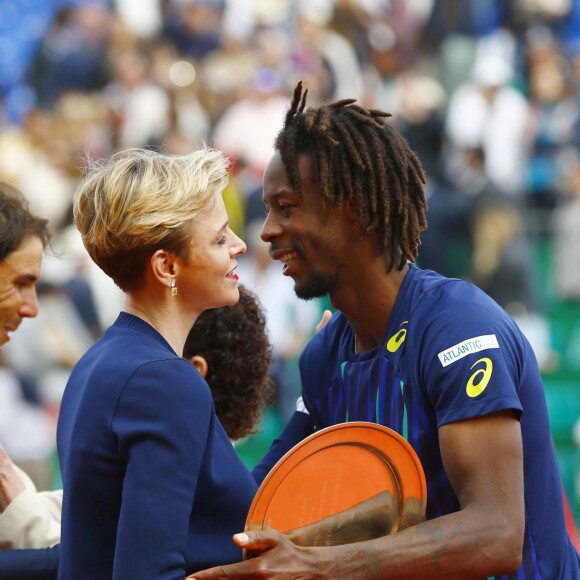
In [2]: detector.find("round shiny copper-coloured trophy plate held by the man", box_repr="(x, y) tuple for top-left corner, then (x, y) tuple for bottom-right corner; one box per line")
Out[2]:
(245, 421), (427, 545)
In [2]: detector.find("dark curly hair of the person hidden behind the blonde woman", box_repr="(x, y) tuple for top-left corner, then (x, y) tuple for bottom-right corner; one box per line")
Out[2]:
(183, 286), (274, 440)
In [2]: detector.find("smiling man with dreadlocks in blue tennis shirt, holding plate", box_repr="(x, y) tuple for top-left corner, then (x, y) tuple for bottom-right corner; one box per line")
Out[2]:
(193, 84), (580, 580)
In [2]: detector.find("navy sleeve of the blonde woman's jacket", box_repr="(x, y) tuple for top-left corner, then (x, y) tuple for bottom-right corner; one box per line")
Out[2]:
(112, 359), (213, 580)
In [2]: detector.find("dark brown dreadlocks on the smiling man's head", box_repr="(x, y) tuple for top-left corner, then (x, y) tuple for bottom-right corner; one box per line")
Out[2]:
(274, 81), (427, 271)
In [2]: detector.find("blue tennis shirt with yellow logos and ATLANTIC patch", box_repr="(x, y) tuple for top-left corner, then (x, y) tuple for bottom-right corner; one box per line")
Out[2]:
(300, 265), (580, 580)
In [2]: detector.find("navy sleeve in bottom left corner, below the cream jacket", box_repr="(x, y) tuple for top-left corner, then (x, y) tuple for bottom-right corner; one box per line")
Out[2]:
(0, 546), (60, 580)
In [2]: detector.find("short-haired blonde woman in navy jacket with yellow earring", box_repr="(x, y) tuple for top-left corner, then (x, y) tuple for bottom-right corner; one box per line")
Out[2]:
(57, 149), (256, 580)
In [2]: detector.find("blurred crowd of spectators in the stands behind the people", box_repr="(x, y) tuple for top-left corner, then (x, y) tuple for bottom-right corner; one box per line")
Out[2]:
(0, 0), (580, 519)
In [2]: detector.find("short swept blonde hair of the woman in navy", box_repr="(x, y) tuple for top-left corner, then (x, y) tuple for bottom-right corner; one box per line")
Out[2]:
(73, 147), (229, 291)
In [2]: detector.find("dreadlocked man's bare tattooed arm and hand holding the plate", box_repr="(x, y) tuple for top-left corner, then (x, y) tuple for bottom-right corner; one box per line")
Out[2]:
(190, 411), (524, 580)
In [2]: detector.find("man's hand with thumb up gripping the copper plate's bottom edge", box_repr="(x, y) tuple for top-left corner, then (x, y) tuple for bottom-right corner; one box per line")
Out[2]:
(188, 530), (333, 580)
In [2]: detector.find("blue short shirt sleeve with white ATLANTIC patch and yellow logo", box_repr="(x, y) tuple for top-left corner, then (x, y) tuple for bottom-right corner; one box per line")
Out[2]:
(417, 293), (527, 427)
